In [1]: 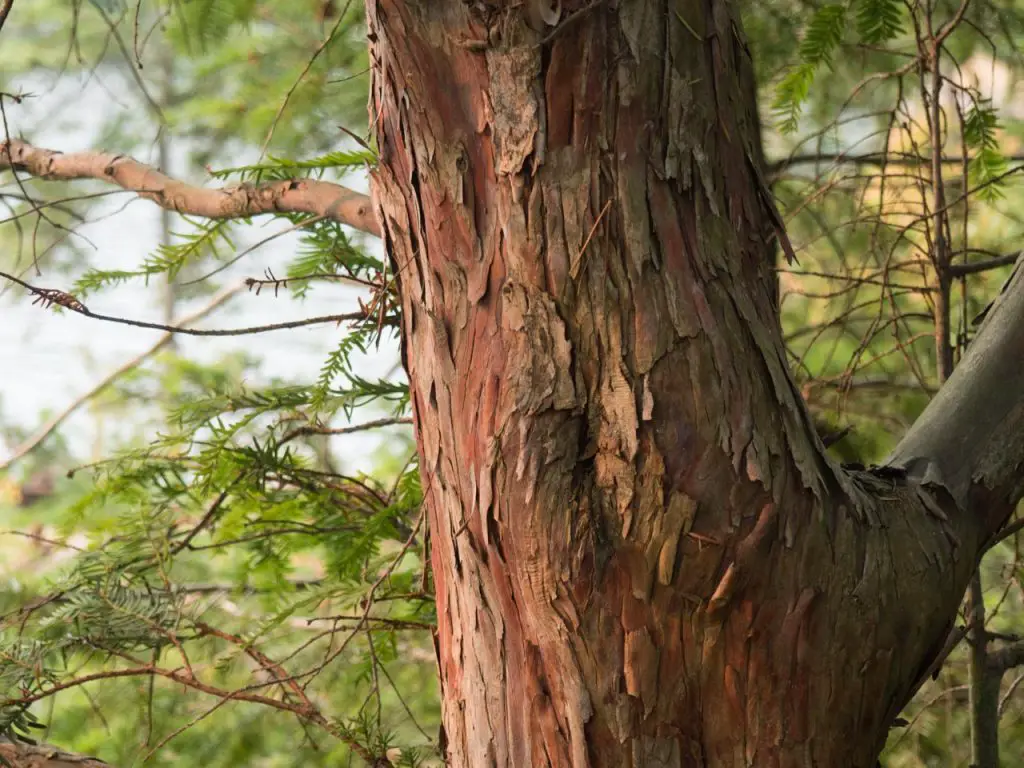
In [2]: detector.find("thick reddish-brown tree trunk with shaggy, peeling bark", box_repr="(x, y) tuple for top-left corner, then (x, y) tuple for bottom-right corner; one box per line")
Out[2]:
(367, 0), (1024, 768)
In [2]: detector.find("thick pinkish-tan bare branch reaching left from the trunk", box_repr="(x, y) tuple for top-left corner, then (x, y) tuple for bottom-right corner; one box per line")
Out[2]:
(0, 139), (380, 237)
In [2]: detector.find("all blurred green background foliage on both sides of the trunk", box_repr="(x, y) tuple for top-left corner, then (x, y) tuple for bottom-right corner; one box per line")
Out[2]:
(0, 0), (1024, 768)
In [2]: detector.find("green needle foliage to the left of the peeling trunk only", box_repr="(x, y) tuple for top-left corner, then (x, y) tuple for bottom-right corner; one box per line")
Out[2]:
(0, 0), (439, 767)
